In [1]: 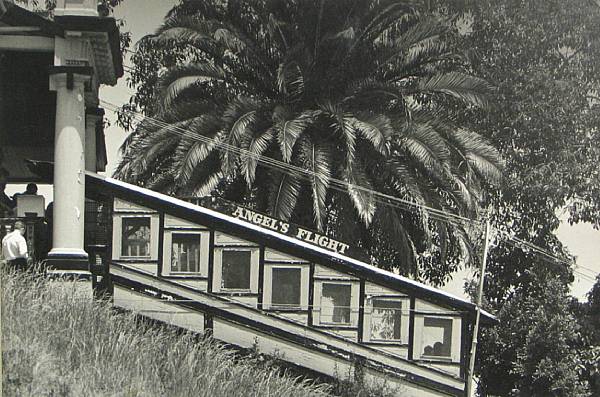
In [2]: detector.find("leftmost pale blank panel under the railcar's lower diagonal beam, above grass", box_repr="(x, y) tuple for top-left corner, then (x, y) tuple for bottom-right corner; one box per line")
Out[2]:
(113, 286), (204, 333)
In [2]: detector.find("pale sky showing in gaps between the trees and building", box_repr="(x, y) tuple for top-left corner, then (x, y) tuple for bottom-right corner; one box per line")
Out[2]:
(6, 0), (600, 300)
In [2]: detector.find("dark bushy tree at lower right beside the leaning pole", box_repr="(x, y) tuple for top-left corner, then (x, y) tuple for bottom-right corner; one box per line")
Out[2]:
(479, 279), (590, 397)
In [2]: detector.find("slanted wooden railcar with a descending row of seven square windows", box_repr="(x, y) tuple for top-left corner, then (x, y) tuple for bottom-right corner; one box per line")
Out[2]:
(86, 174), (493, 396)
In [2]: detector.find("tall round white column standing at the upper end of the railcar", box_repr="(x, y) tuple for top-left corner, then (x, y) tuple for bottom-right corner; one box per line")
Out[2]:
(48, 67), (89, 270)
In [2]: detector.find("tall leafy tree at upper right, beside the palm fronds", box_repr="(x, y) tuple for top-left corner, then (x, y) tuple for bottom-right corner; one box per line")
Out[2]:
(450, 0), (600, 309)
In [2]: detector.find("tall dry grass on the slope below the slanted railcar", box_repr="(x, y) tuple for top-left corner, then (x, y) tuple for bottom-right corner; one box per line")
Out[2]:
(0, 264), (404, 397)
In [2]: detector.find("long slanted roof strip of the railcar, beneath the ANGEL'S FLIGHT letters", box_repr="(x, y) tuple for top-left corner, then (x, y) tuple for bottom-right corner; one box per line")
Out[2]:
(86, 172), (497, 324)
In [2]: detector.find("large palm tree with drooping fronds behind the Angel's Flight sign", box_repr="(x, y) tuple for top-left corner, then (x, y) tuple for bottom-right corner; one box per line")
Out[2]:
(116, 0), (501, 282)
